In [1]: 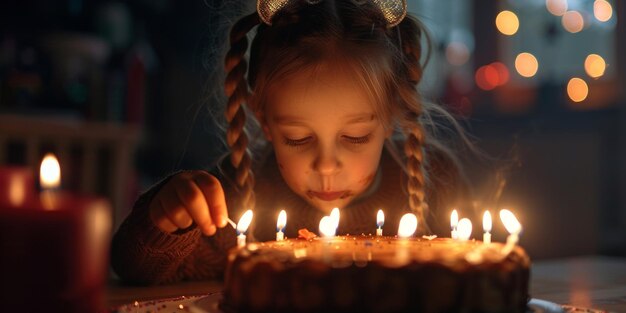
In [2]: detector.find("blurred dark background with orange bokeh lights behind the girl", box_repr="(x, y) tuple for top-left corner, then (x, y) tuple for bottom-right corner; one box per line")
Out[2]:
(0, 0), (626, 258)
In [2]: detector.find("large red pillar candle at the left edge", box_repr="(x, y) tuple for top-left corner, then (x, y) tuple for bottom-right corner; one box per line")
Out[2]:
(0, 154), (111, 312)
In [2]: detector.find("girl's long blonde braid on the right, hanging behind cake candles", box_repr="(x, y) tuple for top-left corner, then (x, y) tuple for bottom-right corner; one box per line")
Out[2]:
(397, 17), (430, 232)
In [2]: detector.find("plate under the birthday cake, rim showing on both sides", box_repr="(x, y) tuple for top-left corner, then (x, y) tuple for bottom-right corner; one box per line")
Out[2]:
(111, 292), (607, 313)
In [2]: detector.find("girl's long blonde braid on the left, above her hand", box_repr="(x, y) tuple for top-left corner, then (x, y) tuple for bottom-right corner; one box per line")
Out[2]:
(224, 12), (259, 209)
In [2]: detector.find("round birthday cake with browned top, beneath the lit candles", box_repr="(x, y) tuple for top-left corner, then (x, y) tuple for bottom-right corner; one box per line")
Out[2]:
(221, 236), (530, 313)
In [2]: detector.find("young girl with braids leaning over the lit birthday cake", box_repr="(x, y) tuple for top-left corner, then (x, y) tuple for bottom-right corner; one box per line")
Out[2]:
(112, 0), (466, 283)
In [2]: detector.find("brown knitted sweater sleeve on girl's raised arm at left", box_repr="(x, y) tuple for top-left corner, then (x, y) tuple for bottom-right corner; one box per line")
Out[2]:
(111, 175), (235, 285)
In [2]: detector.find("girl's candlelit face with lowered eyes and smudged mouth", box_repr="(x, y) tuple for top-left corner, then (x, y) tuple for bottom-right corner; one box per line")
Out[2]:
(259, 67), (389, 212)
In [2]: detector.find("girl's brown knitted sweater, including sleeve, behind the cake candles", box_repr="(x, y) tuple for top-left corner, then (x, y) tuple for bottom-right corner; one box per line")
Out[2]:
(111, 145), (467, 284)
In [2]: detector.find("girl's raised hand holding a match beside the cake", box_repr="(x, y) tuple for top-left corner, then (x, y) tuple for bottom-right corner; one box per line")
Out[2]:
(149, 171), (228, 236)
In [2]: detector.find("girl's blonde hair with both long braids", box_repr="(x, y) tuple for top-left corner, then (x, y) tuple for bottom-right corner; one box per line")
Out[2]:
(225, 0), (466, 229)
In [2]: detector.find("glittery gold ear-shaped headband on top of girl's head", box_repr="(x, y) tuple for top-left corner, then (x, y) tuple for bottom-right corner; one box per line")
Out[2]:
(256, 0), (406, 27)
